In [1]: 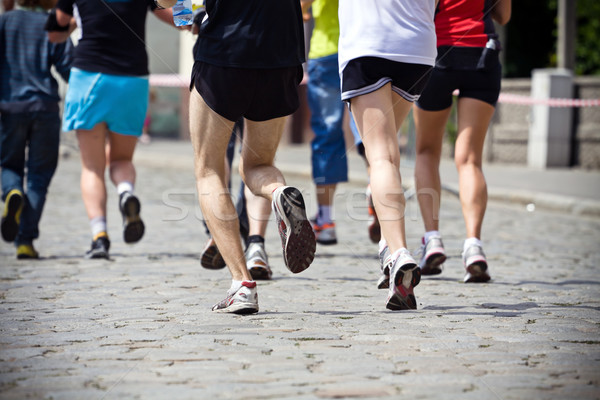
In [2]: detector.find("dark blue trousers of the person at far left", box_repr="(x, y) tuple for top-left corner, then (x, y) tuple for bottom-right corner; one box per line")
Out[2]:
(0, 112), (60, 245)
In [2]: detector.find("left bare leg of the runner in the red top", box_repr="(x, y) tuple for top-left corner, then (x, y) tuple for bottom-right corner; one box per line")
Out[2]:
(413, 106), (451, 232)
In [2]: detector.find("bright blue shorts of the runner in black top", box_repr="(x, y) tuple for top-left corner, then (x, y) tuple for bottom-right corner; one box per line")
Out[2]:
(62, 68), (149, 136)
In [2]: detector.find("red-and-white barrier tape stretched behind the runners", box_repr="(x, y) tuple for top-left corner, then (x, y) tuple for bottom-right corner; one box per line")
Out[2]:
(150, 74), (600, 107)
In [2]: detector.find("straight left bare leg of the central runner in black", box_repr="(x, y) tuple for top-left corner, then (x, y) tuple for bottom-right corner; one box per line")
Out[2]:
(190, 88), (252, 281)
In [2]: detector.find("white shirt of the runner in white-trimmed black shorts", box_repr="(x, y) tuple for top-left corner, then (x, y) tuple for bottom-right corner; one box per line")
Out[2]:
(338, 0), (437, 74)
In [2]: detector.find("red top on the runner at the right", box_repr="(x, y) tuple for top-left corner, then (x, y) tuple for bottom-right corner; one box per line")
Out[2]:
(435, 0), (496, 47)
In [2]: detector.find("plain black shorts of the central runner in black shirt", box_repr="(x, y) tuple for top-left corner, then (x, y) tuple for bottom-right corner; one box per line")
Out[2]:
(190, 61), (303, 121)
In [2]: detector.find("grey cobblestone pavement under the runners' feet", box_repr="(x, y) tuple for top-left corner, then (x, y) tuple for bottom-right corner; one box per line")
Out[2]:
(0, 138), (600, 400)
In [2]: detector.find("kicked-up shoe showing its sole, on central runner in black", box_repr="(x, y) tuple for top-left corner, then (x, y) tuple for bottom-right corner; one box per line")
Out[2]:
(272, 186), (317, 274)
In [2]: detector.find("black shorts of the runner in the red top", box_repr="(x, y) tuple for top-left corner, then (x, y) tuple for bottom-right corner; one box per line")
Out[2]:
(417, 63), (502, 111)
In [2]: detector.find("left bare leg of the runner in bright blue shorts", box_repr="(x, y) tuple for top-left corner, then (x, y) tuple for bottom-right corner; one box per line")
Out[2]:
(77, 123), (108, 220)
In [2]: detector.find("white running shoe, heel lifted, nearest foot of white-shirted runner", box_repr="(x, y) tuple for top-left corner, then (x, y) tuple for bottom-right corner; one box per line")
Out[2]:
(386, 250), (421, 310)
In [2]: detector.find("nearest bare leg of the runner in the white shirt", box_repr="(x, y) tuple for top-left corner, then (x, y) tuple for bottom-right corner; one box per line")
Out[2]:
(352, 84), (411, 253)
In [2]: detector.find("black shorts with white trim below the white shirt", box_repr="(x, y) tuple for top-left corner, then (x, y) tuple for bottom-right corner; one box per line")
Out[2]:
(342, 57), (433, 102)
